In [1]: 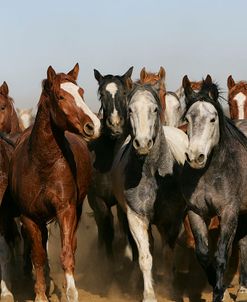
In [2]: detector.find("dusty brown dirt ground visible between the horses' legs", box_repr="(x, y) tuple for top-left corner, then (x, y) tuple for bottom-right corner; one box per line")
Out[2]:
(5, 202), (240, 302)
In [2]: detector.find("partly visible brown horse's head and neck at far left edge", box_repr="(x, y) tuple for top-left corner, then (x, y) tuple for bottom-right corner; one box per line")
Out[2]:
(0, 82), (21, 134)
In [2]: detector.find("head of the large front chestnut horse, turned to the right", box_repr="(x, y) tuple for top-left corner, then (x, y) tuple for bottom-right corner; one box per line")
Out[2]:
(43, 64), (100, 140)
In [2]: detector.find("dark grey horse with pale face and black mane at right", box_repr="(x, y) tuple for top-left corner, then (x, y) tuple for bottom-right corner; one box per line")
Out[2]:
(181, 75), (247, 302)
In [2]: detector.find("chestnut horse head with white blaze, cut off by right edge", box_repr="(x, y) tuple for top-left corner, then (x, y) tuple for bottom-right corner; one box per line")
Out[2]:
(227, 75), (247, 120)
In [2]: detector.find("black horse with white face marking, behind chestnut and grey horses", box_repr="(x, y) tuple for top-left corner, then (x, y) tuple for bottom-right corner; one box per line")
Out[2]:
(88, 67), (133, 259)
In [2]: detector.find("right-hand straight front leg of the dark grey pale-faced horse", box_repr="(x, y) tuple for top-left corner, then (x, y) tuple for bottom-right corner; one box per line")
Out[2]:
(213, 205), (238, 302)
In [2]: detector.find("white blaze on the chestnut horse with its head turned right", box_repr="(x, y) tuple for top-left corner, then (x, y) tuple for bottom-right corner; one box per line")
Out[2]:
(60, 82), (100, 135)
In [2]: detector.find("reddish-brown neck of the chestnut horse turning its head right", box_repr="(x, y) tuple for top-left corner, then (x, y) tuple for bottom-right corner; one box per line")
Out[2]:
(29, 99), (65, 163)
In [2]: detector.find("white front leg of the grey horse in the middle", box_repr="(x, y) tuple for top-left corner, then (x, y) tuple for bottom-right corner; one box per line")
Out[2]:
(127, 206), (157, 302)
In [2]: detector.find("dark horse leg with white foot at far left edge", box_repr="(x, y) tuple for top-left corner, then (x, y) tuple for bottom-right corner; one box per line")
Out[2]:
(0, 235), (14, 301)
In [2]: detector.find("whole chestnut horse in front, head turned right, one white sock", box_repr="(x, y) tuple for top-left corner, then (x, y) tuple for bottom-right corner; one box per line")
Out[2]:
(9, 64), (100, 302)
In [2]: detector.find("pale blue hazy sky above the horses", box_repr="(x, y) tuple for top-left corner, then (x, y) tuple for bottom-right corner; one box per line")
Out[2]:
(0, 0), (247, 111)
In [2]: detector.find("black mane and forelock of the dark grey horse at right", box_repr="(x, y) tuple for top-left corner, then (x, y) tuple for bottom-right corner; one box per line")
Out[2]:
(184, 80), (247, 150)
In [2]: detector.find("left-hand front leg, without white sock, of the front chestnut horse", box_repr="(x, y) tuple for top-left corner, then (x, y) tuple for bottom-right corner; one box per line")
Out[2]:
(21, 216), (48, 302)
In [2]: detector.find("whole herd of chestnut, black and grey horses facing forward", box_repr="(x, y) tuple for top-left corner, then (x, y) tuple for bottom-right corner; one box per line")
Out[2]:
(0, 64), (247, 302)
